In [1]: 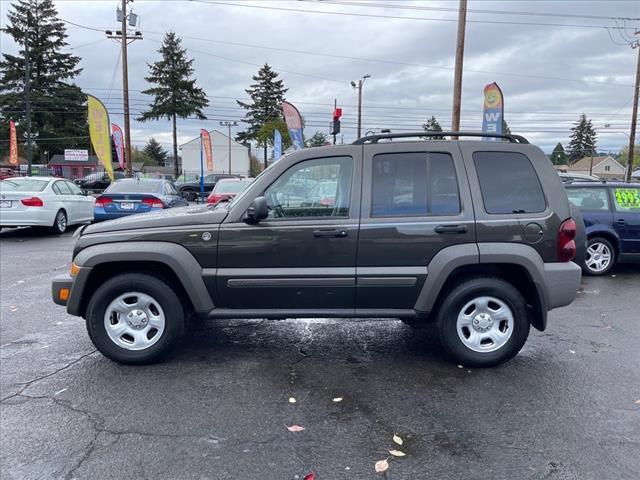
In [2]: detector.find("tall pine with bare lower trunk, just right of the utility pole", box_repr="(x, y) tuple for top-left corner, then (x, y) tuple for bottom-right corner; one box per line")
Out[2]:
(138, 32), (209, 178)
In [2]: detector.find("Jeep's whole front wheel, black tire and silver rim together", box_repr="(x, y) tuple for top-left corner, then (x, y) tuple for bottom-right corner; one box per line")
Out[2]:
(87, 273), (185, 364)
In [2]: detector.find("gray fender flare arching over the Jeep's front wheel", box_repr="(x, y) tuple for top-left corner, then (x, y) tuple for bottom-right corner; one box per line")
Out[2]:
(69, 242), (214, 312)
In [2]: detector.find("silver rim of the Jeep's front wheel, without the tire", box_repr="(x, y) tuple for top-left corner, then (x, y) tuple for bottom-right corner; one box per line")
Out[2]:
(104, 292), (166, 350)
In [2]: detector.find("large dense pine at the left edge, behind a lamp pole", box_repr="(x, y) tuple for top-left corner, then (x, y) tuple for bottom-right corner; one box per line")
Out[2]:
(0, 0), (88, 159)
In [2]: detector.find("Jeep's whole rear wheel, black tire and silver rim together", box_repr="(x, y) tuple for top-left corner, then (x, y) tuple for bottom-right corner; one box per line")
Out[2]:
(438, 277), (529, 367)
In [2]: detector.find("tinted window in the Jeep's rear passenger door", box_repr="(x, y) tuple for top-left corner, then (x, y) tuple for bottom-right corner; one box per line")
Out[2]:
(371, 152), (460, 217)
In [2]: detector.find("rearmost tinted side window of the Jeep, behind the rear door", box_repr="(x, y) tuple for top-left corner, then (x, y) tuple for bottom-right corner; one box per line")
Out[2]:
(473, 152), (546, 214)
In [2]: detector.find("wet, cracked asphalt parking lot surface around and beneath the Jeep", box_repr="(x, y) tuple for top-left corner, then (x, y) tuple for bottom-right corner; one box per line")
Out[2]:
(0, 229), (640, 480)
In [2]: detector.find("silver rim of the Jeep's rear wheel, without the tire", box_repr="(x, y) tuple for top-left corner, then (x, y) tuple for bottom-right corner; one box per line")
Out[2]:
(456, 296), (514, 353)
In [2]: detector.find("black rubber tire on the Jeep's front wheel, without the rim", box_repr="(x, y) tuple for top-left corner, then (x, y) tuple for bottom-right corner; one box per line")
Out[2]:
(86, 273), (185, 365)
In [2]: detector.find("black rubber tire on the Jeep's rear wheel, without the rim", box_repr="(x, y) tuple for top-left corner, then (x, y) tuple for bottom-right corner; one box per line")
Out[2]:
(437, 276), (529, 367)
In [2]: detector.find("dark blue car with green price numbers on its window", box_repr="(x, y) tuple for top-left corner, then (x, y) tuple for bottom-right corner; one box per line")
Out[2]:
(566, 182), (640, 275)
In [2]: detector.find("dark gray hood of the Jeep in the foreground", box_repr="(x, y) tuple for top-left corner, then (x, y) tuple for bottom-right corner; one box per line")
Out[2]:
(82, 205), (227, 235)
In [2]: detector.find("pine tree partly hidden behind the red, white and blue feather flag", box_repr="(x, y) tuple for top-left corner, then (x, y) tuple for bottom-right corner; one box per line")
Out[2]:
(236, 63), (287, 165)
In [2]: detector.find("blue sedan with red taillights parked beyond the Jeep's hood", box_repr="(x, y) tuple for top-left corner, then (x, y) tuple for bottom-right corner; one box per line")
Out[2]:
(94, 178), (189, 222)
